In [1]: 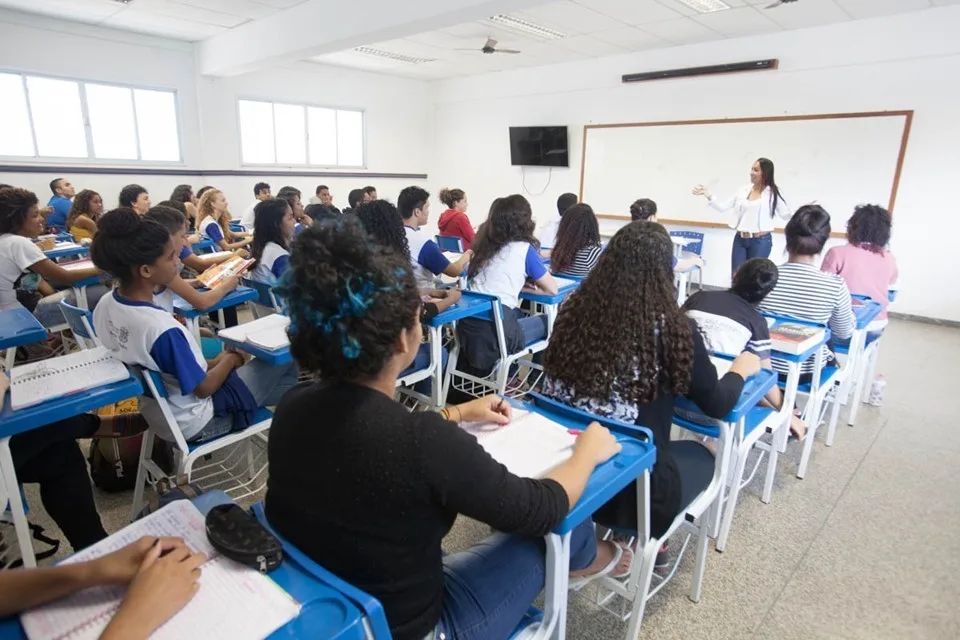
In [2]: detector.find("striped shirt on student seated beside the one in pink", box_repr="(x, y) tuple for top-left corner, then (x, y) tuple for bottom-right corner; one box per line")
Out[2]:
(759, 262), (857, 373)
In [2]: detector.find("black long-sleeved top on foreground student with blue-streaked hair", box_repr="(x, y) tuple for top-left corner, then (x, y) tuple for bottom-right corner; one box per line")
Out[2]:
(266, 383), (570, 640)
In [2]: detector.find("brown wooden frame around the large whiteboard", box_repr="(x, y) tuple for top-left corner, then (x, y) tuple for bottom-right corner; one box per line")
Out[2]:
(578, 109), (913, 238)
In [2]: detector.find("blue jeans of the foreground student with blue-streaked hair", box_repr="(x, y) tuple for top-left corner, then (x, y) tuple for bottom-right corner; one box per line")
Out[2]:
(428, 520), (597, 640)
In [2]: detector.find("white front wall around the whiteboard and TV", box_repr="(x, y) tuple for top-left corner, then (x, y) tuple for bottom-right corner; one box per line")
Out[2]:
(429, 7), (960, 320)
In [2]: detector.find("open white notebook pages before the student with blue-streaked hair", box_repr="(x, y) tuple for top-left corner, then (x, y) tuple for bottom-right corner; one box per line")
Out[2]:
(463, 412), (577, 478)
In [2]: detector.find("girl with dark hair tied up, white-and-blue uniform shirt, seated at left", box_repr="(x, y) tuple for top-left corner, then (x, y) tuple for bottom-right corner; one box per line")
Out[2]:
(90, 209), (297, 442)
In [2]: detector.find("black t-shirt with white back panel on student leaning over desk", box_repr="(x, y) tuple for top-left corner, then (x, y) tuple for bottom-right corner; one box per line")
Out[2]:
(683, 290), (771, 360)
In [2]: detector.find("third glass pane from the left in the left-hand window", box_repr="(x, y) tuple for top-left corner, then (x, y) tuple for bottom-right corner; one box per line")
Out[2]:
(84, 84), (137, 160)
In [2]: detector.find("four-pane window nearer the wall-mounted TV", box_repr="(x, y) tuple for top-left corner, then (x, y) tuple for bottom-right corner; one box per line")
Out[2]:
(239, 100), (364, 167)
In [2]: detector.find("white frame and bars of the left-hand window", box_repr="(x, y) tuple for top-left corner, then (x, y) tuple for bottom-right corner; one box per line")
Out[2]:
(0, 67), (185, 167)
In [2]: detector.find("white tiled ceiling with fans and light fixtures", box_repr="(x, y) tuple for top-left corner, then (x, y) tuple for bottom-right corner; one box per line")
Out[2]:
(0, 0), (960, 79)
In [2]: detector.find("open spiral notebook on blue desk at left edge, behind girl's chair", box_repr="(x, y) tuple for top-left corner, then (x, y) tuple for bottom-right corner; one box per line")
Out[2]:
(10, 347), (130, 411)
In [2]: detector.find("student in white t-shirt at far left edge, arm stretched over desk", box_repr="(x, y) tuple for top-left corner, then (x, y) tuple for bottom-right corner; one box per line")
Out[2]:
(0, 189), (107, 328)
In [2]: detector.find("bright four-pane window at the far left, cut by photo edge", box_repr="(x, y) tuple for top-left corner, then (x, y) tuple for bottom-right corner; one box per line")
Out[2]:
(0, 73), (180, 162)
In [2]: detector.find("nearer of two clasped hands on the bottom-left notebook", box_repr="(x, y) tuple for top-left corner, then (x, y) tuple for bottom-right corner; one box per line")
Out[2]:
(101, 544), (207, 640)
